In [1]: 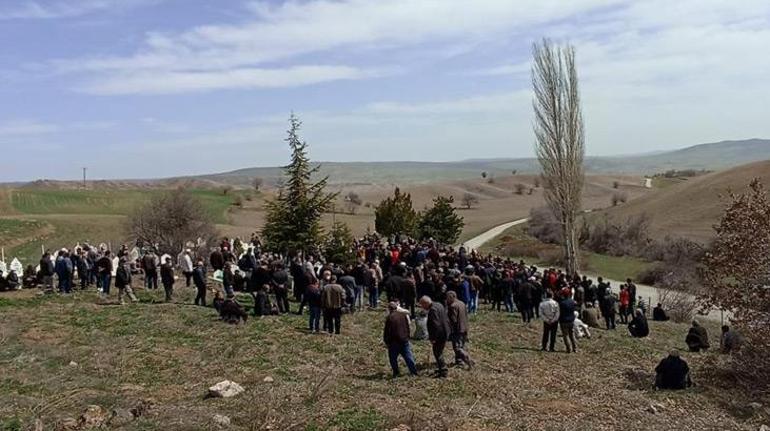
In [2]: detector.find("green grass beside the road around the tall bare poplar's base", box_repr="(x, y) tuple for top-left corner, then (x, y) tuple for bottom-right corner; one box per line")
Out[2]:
(481, 224), (654, 280)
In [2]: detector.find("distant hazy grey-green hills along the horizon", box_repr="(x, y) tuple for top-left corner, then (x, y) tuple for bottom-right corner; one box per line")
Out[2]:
(190, 139), (770, 186)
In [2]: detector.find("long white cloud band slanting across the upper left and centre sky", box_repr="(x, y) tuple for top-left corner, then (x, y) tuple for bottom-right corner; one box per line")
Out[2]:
(54, 0), (619, 94)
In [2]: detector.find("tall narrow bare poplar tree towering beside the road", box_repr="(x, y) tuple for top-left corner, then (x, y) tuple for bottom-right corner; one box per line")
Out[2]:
(532, 39), (585, 274)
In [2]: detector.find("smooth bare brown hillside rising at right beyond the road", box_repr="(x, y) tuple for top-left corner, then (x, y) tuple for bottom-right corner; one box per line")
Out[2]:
(606, 161), (770, 242)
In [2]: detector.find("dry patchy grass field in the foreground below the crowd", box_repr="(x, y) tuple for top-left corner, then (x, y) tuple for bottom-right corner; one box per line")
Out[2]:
(0, 289), (763, 431)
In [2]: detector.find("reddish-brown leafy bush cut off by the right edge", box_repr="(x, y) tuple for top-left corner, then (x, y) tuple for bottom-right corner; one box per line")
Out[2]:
(701, 179), (770, 389)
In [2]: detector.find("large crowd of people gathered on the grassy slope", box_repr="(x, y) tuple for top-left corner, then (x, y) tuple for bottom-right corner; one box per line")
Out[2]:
(3, 235), (739, 388)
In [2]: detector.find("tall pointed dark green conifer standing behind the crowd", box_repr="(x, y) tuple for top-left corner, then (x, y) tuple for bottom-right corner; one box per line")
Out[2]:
(262, 113), (336, 252)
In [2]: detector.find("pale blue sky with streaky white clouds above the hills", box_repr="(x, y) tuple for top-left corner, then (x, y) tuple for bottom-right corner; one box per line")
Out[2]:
(0, 0), (770, 181)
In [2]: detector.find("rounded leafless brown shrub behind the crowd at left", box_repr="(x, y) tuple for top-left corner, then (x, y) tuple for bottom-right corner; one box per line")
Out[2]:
(126, 189), (217, 256)
